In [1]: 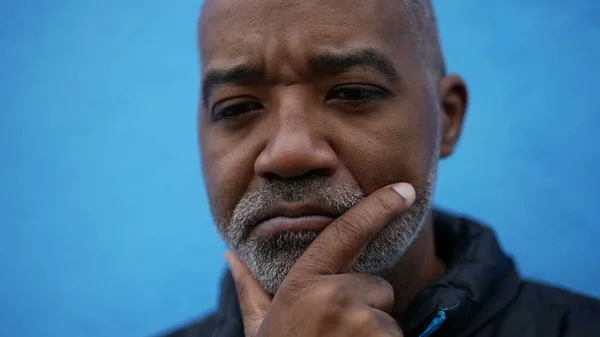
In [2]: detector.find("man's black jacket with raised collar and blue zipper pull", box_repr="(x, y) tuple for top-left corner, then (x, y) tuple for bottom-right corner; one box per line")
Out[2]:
(158, 212), (600, 337)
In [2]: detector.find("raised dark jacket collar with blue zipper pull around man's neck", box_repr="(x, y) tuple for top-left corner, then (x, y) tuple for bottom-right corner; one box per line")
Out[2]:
(213, 211), (520, 337)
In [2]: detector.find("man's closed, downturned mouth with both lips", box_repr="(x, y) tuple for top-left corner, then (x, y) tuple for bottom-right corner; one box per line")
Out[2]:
(254, 204), (339, 236)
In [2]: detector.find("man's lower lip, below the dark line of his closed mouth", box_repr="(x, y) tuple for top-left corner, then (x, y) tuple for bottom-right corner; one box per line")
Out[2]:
(255, 215), (334, 235)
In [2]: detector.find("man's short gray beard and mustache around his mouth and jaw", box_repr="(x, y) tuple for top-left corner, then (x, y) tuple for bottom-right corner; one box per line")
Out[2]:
(218, 168), (435, 294)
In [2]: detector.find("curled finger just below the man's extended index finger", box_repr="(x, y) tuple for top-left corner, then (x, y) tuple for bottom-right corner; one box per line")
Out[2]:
(334, 273), (394, 313)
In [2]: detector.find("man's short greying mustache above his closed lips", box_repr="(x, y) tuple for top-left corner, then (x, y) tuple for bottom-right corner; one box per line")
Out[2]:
(228, 175), (365, 236)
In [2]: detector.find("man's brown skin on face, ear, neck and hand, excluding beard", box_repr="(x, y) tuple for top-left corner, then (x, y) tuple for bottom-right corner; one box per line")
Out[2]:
(199, 0), (467, 336)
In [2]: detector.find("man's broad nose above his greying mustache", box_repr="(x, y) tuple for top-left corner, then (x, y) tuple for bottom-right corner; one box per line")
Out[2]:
(254, 111), (338, 179)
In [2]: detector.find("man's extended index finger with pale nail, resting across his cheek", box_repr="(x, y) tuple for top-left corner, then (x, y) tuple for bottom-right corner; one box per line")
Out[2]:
(289, 183), (416, 278)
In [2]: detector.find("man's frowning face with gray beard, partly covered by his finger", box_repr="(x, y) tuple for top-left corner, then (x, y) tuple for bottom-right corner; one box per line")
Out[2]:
(199, 0), (460, 293)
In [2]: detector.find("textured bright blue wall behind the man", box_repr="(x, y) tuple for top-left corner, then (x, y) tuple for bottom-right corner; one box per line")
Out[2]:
(0, 0), (600, 337)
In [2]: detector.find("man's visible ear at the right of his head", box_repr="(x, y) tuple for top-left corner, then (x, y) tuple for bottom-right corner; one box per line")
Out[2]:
(438, 75), (468, 158)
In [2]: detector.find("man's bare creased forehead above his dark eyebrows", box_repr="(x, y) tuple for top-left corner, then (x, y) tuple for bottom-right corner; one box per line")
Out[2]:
(199, 0), (408, 68)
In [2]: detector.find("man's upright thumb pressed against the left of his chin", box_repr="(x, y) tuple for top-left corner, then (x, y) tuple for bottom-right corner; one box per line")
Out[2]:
(225, 250), (273, 337)
